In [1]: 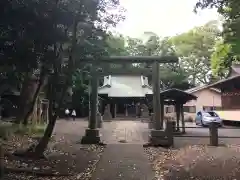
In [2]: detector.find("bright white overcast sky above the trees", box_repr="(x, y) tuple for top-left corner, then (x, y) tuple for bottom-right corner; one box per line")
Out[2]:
(116, 0), (219, 38)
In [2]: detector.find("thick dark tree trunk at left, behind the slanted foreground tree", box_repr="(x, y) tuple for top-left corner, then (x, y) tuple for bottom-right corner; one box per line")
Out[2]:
(16, 74), (39, 124)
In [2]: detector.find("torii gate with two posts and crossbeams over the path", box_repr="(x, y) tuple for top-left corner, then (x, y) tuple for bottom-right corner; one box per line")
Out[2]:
(81, 56), (178, 144)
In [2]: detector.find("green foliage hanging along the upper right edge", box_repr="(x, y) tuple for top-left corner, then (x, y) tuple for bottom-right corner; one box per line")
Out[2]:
(195, 0), (240, 77)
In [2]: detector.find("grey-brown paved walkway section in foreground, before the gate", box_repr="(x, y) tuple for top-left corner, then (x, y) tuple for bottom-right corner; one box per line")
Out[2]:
(91, 144), (154, 180)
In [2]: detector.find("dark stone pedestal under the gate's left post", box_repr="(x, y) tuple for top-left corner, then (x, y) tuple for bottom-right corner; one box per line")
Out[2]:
(81, 129), (100, 144)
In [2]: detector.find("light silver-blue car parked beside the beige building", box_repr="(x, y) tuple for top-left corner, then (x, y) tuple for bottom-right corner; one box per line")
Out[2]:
(195, 111), (223, 126)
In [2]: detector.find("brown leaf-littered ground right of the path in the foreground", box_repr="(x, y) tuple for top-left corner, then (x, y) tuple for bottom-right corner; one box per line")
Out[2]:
(145, 145), (240, 180)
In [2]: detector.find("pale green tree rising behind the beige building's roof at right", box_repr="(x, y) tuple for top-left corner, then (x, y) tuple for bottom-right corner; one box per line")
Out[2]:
(171, 21), (220, 85)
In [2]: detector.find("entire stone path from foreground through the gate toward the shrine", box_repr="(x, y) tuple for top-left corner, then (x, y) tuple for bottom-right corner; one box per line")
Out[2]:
(92, 121), (154, 180)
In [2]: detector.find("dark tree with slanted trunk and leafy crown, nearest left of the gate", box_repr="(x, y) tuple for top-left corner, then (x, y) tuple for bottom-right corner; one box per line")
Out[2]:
(12, 0), (124, 158)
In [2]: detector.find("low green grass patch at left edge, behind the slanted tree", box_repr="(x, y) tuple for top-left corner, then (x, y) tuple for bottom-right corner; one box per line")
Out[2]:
(0, 122), (46, 140)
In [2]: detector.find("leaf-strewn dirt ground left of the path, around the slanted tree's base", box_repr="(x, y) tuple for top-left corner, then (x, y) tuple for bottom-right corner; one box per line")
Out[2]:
(1, 121), (103, 180)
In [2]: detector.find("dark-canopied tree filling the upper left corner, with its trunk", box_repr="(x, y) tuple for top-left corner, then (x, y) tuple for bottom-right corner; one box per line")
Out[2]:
(0, 0), (73, 124)
